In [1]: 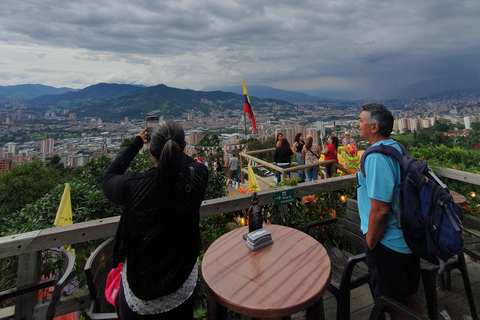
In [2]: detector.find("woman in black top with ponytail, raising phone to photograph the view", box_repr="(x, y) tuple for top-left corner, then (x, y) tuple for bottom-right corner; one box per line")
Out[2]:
(102, 121), (208, 320)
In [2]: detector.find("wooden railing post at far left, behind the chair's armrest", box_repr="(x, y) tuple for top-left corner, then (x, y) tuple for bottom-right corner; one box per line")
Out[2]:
(14, 251), (40, 320)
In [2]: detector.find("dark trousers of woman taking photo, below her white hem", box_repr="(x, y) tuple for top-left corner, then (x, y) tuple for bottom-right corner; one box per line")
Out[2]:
(117, 284), (196, 320)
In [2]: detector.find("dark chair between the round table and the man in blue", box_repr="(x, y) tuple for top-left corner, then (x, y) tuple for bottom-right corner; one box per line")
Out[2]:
(304, 199), (370, 320)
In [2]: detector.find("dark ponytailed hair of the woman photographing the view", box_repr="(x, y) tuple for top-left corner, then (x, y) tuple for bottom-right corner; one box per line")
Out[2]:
(150, 121), (185, 190)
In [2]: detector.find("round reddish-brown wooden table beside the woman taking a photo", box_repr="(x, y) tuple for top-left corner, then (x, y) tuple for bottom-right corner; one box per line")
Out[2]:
(202, 225), (331, 319)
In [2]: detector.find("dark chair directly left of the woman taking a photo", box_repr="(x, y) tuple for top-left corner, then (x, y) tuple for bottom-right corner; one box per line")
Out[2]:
(84, 238), (118, 320)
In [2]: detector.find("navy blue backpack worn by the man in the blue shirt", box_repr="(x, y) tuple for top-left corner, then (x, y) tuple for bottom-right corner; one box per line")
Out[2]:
(360, 142), (463, 272)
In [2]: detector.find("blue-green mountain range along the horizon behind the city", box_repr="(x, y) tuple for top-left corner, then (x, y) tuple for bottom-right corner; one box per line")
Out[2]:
(0, 83), (480, 121)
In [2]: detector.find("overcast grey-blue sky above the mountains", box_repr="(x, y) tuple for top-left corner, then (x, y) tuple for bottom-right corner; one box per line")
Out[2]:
(0, 0), (480, 98)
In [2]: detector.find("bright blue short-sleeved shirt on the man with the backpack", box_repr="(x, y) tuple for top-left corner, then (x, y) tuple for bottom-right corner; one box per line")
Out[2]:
(357, 139), (412, 254)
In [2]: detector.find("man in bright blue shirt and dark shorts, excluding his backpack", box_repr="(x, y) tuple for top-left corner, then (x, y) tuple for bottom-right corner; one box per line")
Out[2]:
(356, 103), (422, 319)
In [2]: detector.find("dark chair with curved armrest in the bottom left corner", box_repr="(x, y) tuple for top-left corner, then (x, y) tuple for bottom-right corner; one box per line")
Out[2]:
(0, 249), (75, 320)
